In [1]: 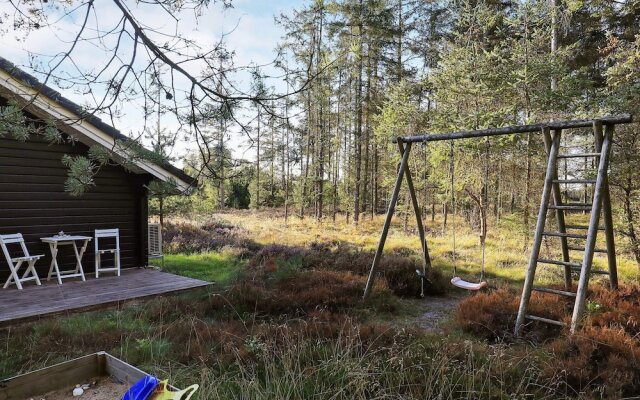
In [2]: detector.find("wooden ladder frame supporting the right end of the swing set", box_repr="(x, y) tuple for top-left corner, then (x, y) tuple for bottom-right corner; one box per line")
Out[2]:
(515, 120), (618, 336)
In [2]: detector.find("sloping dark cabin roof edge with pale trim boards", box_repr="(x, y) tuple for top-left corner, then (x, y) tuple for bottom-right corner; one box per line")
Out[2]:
(0, 57), (197, 191)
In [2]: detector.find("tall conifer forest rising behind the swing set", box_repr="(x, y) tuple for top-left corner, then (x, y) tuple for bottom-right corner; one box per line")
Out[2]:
(160, 0), (640, 263)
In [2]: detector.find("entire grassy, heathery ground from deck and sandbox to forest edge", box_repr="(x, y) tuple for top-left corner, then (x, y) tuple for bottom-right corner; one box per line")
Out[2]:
(0, 211), (640, 399)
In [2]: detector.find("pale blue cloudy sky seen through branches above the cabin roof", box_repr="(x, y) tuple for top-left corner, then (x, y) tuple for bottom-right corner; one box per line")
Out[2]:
(0, 0), (304, 165)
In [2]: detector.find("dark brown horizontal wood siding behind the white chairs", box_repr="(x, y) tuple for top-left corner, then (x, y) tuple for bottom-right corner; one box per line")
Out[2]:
(0, 137), (150, 287)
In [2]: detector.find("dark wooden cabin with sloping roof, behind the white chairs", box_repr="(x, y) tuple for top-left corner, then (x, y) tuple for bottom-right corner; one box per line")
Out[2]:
(0, 58), (195, 287)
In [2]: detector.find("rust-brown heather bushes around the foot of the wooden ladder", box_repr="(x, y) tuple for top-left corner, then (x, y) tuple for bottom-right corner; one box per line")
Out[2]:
(456, 285), (640, 398)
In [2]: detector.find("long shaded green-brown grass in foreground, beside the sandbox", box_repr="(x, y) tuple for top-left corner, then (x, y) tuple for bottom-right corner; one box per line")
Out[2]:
(0, 293), (568, 399)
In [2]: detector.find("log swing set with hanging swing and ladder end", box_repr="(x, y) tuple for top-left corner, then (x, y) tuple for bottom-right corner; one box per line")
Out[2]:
(364, 114), (632, 335)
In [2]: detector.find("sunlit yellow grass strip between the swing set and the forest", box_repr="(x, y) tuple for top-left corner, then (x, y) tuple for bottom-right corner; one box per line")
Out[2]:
(218, 211), (640, 286)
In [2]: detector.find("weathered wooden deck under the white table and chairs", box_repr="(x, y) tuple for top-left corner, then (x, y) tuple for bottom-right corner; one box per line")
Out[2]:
(0, 268), (211, 325)
